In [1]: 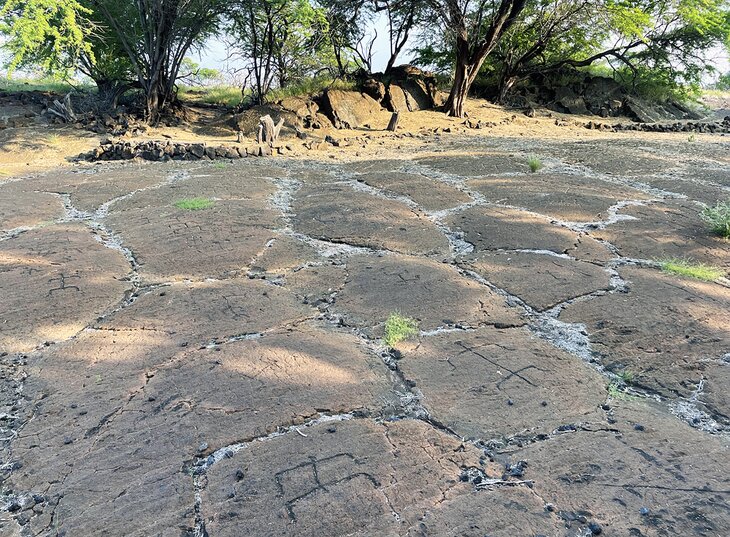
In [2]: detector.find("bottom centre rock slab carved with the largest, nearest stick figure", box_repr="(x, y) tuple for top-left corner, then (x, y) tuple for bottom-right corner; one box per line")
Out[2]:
(201, 420), (555, 537)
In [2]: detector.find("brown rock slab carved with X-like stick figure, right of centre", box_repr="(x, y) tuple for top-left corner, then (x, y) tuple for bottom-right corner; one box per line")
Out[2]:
(398, 327), (606, 441)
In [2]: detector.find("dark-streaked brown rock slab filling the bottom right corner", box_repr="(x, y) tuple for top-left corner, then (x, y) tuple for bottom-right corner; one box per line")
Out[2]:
(510, 401), (730, 537)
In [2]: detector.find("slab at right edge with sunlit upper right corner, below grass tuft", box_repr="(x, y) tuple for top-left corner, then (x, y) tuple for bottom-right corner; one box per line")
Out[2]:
(560, 268), (730, 419)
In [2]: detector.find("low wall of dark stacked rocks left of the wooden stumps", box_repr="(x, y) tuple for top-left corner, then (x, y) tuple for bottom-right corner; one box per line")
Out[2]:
(79, 140), (291, 162)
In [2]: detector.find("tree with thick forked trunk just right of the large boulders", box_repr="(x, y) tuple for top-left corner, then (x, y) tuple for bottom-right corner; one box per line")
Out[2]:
(429, 0), (527, 117)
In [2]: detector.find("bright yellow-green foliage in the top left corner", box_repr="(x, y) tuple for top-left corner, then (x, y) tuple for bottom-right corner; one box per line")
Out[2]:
(0, 0), (94, 73)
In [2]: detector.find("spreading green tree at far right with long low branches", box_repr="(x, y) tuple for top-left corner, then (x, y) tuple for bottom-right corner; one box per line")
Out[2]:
(490, 0), (730, 101)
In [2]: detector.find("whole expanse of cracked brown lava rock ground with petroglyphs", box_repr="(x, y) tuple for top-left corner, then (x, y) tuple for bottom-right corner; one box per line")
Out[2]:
(0, 102), (730, 537)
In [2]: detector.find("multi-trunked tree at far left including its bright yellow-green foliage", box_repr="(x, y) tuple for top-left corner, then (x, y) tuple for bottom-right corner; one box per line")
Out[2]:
(0, 0), (226, 122)
